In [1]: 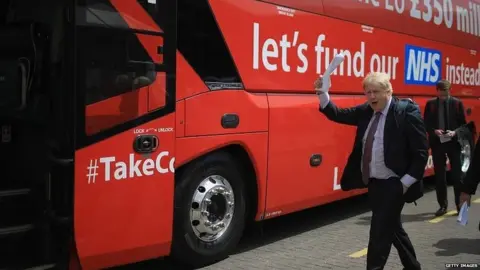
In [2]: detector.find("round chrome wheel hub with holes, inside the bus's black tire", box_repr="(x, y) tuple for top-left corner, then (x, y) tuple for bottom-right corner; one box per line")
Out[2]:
(190, 175), (235, 242)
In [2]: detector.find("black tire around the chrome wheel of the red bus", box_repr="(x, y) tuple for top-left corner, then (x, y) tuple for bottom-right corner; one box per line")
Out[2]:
(172, 152), (246, 268)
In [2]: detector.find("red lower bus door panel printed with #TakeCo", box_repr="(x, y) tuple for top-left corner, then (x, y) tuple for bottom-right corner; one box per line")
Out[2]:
(74, 113), (175, 269)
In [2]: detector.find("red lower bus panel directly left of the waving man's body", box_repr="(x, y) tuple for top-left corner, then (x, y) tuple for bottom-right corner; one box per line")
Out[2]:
(265, 94), (364, 218)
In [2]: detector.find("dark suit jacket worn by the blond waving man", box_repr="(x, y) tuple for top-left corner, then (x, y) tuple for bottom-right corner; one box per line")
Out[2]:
(320, 98), (428, 194)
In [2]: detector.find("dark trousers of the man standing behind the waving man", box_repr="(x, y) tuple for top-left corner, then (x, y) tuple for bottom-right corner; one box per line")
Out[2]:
(432, 139), (462, 210)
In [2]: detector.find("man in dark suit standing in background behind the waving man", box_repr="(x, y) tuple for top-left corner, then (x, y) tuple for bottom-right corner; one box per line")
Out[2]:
(424, 80), (466, 216)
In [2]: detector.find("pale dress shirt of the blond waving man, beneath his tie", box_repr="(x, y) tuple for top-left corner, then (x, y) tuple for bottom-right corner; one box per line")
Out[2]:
(319, 93), (417, 187)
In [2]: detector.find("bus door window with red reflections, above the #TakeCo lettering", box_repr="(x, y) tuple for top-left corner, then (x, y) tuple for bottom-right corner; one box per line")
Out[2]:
(77, 0), (165, 135)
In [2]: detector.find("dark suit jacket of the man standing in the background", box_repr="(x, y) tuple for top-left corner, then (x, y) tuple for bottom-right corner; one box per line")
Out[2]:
(424, 97), (467, 147)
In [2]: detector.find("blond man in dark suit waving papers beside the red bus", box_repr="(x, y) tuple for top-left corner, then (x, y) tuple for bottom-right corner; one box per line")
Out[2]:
(314, 72), (428, 270)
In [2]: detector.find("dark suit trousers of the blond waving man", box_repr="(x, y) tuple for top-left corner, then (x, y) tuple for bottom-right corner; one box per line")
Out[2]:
(367, 178), (421, 270)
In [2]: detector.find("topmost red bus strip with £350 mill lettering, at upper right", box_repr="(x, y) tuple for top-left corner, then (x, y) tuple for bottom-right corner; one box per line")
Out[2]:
(320, 0), (480, 49)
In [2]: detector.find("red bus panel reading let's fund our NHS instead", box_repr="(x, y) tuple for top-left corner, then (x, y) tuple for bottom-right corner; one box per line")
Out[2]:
(210, 0), (480, 97)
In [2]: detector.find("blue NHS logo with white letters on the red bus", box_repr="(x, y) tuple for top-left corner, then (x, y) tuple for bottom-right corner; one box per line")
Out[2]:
(404, 44), (442, 85)
